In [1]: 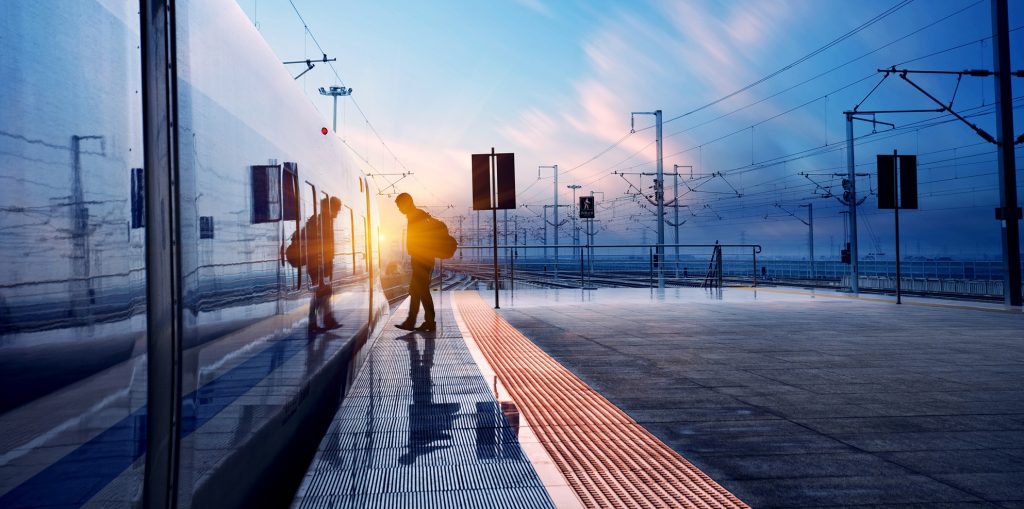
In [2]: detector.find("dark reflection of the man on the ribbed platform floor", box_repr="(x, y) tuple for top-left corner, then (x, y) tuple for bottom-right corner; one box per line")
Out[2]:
(397, 334), (462, 465)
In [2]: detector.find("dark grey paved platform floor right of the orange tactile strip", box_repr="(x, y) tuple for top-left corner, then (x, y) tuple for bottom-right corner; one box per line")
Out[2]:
(493, 289), (1024, 508)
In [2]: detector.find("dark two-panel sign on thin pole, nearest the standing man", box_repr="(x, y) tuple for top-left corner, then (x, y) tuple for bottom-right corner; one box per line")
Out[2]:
(472, 147), (515, 309)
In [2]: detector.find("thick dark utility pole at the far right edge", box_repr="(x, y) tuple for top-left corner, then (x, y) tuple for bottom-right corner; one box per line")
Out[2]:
(992, 0), (1021, 307)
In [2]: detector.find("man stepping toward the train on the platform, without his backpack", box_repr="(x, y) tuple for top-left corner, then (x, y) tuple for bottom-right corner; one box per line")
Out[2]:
(394, 193), (437, 332)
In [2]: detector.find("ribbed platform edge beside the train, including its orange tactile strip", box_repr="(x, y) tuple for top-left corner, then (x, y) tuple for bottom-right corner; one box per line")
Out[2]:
(293, 292), (748, 509)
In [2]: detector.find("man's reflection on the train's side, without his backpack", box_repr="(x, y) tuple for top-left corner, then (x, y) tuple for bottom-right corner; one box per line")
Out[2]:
(305, 197), (341, 333)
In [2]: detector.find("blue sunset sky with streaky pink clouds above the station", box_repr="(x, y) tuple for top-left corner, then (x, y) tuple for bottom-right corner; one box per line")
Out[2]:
(238, 0), (1024, 259)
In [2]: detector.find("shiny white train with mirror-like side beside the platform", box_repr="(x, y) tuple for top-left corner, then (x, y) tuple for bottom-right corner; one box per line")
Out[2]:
(0, 0), (389, 508)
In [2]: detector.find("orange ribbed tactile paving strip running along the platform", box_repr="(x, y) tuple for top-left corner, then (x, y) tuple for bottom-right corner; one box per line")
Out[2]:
(455, 292), (749, 508)
